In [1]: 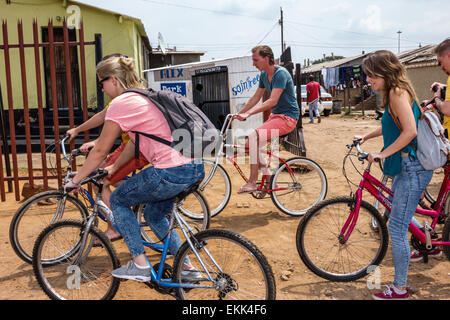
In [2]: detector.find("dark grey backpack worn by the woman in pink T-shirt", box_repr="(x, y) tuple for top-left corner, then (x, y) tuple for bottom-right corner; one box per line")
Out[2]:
(124, 88), (220, 159)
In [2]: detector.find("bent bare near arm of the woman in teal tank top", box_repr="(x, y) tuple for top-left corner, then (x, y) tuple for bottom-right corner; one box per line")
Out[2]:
(380, 89), (417, 159)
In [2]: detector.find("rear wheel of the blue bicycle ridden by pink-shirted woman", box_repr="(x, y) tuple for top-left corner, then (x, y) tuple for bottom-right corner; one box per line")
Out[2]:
(173, 229), (276, 300)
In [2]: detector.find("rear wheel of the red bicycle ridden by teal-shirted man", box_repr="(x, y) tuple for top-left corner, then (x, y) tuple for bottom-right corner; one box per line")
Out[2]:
(270, 158), (328, 216)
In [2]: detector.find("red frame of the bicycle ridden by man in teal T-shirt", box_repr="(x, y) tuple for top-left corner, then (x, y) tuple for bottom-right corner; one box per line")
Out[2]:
(199, 114), (298, 192)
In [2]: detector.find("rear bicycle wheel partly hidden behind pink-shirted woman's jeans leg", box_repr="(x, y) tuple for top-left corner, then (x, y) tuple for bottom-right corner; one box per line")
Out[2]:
(136, 191), (211, 251)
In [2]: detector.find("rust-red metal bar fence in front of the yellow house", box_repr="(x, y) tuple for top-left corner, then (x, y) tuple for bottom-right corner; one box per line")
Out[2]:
(0, 20), (103, 201)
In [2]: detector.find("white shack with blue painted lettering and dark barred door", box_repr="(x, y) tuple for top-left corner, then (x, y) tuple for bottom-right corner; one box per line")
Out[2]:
(143, 56), (263, 143)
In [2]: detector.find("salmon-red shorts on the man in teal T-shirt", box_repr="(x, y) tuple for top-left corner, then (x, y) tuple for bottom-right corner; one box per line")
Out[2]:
(256, 113), (297, 141)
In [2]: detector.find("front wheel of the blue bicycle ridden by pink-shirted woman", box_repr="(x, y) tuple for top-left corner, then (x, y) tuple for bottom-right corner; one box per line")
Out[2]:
(33, 220), (120, 300)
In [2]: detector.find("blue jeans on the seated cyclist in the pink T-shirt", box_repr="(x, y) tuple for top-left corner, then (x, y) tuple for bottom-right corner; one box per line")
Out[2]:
(110, 162), (205, 258)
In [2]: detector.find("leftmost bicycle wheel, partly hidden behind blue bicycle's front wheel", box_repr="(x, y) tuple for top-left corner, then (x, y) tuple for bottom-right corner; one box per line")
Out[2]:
(9, 190), (88, 264)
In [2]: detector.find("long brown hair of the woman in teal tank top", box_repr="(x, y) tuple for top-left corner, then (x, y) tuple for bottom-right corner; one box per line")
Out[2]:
(362, 50), (417, 108)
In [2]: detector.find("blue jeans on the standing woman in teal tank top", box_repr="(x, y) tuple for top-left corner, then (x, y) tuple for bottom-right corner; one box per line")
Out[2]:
(389, 156), (433, 287)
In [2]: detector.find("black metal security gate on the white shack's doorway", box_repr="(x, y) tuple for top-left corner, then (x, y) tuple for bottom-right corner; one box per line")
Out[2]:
(192, 66), (230, 129)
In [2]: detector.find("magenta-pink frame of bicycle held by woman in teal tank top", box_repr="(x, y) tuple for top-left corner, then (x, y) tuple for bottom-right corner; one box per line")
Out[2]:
(340, 159), (450, 246)
